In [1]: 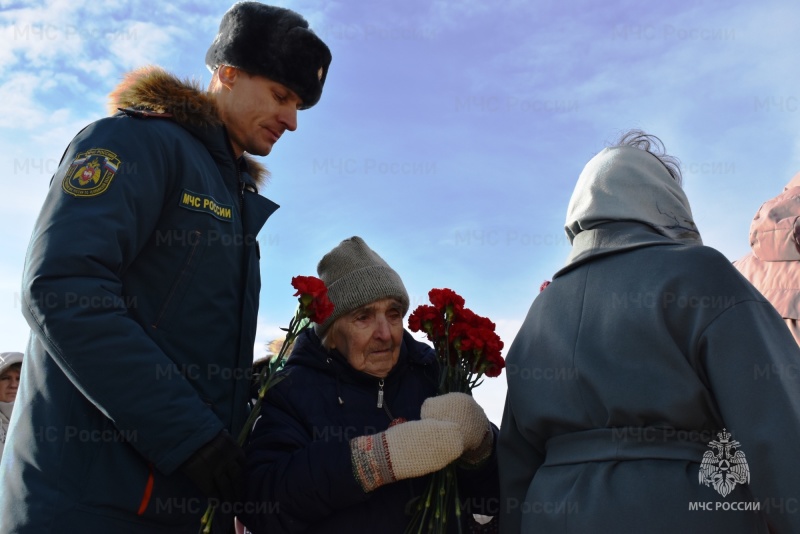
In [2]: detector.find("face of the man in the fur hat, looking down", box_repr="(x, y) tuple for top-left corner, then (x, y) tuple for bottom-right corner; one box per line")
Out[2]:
(217, 65), (302, 156)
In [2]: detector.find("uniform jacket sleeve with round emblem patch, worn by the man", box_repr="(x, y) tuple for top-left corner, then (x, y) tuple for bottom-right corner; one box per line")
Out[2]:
(22, 116), (223, 474)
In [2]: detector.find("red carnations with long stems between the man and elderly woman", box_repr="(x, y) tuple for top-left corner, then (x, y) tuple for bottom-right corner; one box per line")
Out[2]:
(200, 276), (333, 534)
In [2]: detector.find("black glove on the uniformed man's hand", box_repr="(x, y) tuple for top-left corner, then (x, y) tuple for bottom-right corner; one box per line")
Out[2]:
(180, 430), (245, 501)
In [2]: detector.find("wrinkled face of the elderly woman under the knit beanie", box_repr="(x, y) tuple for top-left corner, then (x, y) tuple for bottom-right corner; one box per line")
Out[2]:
(331, 299), (403, 378)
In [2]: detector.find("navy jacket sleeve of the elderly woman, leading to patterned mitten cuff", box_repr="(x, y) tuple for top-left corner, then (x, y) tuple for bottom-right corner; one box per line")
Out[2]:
(239, 380), (370, 532)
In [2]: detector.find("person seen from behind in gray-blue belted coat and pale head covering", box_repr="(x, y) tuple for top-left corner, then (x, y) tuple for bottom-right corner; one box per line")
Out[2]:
(498, 132), (800, 534)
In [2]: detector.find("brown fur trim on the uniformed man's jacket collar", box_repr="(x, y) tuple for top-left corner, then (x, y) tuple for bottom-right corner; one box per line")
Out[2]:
(108, 65), (269, 186)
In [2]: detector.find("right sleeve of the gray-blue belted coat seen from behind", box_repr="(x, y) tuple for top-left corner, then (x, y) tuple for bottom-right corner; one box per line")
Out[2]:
(699, 301), (800, 532)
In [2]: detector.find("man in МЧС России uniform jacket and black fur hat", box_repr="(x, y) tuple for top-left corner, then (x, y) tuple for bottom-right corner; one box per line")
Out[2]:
(0, 2), (331, 534)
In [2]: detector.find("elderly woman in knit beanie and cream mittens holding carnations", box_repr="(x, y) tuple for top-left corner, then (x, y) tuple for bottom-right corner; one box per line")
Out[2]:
(239, 237), (499, 534)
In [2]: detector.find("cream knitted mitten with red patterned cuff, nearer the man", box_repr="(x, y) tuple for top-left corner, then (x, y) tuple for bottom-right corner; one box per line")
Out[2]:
(350, 419), (464, 492)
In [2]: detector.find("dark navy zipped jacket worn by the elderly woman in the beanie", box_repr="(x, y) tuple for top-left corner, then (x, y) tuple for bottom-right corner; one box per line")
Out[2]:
(240, 329), (499, 534)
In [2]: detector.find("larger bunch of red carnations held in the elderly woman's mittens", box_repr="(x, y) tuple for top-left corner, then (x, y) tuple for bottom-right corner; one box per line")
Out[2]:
(407, 289), (506, 533)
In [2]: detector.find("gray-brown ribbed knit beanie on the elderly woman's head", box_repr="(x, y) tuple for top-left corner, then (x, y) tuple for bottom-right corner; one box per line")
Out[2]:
(314, 236), (408, 337)
